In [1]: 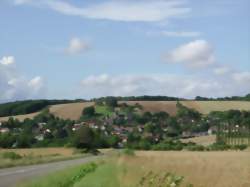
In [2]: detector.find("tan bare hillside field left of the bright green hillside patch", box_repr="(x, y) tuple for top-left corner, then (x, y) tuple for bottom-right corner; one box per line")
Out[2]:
(49, 102), (94, 120)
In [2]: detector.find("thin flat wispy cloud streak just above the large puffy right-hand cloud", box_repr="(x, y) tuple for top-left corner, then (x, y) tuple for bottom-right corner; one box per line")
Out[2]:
(147, 31), (201, 38)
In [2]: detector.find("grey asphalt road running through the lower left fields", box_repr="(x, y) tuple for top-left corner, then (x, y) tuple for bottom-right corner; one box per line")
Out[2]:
(0, 156), (100, 187)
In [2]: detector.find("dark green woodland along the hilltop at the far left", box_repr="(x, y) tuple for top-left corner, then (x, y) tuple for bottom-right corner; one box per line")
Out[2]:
(0, 100), (83, 117)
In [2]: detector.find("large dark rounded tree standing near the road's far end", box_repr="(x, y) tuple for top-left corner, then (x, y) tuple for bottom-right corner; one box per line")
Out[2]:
(73, 126), (95, 149)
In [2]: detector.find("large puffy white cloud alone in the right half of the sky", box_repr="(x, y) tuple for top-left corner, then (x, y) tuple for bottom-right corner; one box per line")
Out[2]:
(165, 40), (216, 68)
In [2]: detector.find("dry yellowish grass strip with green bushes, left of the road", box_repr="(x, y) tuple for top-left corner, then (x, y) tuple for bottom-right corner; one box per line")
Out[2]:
(0, 148), (87, 168)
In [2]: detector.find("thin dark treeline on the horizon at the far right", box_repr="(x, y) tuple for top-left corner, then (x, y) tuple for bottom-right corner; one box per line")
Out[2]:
(195, 94), (250, 101)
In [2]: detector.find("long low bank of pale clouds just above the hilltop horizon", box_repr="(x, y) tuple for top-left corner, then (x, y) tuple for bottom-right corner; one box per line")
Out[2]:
(79, 72), (250, 98)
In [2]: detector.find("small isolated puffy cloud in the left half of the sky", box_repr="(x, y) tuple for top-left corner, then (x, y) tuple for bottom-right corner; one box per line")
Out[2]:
(66, 37), (90, 55)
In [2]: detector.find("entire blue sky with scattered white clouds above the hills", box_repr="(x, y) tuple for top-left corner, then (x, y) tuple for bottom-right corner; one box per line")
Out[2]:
(0, 0), (250, 102)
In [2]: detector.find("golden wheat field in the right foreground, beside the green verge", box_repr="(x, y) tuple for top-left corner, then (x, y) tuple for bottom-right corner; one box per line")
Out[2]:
(119, 151), (250, 187)
